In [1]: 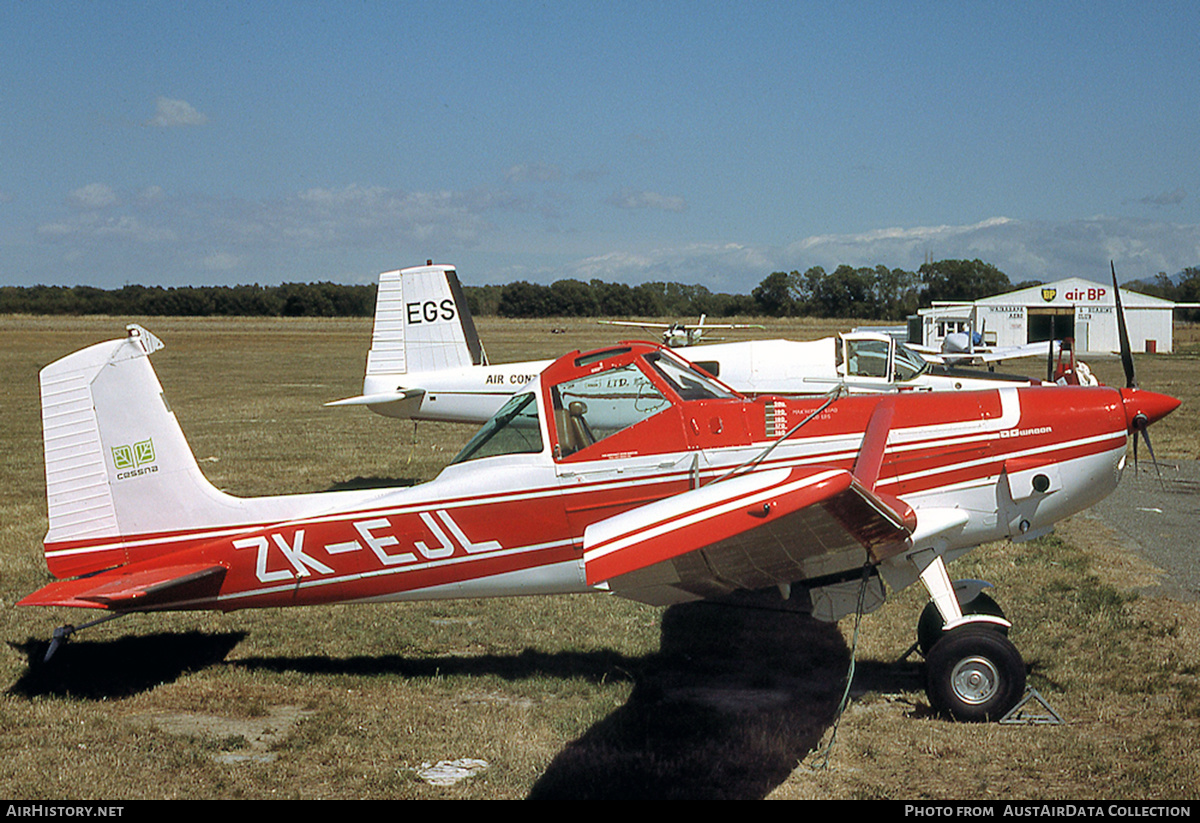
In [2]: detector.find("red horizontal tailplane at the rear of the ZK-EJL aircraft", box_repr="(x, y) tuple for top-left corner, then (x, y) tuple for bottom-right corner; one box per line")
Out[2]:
(17, 564), (226, 612)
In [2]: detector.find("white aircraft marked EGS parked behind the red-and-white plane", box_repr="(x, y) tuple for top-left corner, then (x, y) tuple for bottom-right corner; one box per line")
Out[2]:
(326, 263), (1046, 423)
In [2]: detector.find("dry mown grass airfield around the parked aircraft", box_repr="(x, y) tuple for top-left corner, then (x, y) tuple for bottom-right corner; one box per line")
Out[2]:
(0, 317), (1200, 800)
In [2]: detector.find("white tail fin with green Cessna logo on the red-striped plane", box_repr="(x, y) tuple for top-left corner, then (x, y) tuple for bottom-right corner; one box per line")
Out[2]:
(41, 325), (246, 577)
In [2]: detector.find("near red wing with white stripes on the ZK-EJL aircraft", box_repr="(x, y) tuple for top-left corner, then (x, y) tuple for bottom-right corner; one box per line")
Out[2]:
(583, 468), (916, 605)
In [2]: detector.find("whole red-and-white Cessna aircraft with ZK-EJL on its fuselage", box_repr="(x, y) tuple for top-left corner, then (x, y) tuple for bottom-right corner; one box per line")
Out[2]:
(18, 289), (1178, 720)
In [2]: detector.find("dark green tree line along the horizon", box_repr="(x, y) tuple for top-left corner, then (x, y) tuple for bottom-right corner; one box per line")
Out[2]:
(0, 259), (1176, 322)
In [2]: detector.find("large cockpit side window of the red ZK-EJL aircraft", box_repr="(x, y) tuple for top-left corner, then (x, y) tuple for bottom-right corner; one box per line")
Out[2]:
(550, 364), (671, 457)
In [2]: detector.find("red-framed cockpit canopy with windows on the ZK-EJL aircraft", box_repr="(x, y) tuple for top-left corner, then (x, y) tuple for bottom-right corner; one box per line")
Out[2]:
(452, 343), (744, 463)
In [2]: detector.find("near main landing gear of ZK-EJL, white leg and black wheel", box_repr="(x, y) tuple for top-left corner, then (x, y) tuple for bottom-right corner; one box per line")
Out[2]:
(917, 558), (1025, 722)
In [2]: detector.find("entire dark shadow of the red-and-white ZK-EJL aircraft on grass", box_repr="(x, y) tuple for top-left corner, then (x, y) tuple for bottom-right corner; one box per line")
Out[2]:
(10, 594), (920, 799)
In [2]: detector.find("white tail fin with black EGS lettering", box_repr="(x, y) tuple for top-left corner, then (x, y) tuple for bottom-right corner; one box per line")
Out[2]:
(364, 265), (487, 381)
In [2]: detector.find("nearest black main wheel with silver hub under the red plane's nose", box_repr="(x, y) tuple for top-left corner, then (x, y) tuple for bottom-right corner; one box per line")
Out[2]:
(925, 624), (1025, 722)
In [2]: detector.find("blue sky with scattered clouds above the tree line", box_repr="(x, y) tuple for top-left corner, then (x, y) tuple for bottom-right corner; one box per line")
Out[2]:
(0, 0), (1200, 293)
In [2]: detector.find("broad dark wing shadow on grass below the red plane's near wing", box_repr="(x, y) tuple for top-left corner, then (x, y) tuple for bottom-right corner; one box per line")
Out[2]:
(529, 594), (919, 799)
